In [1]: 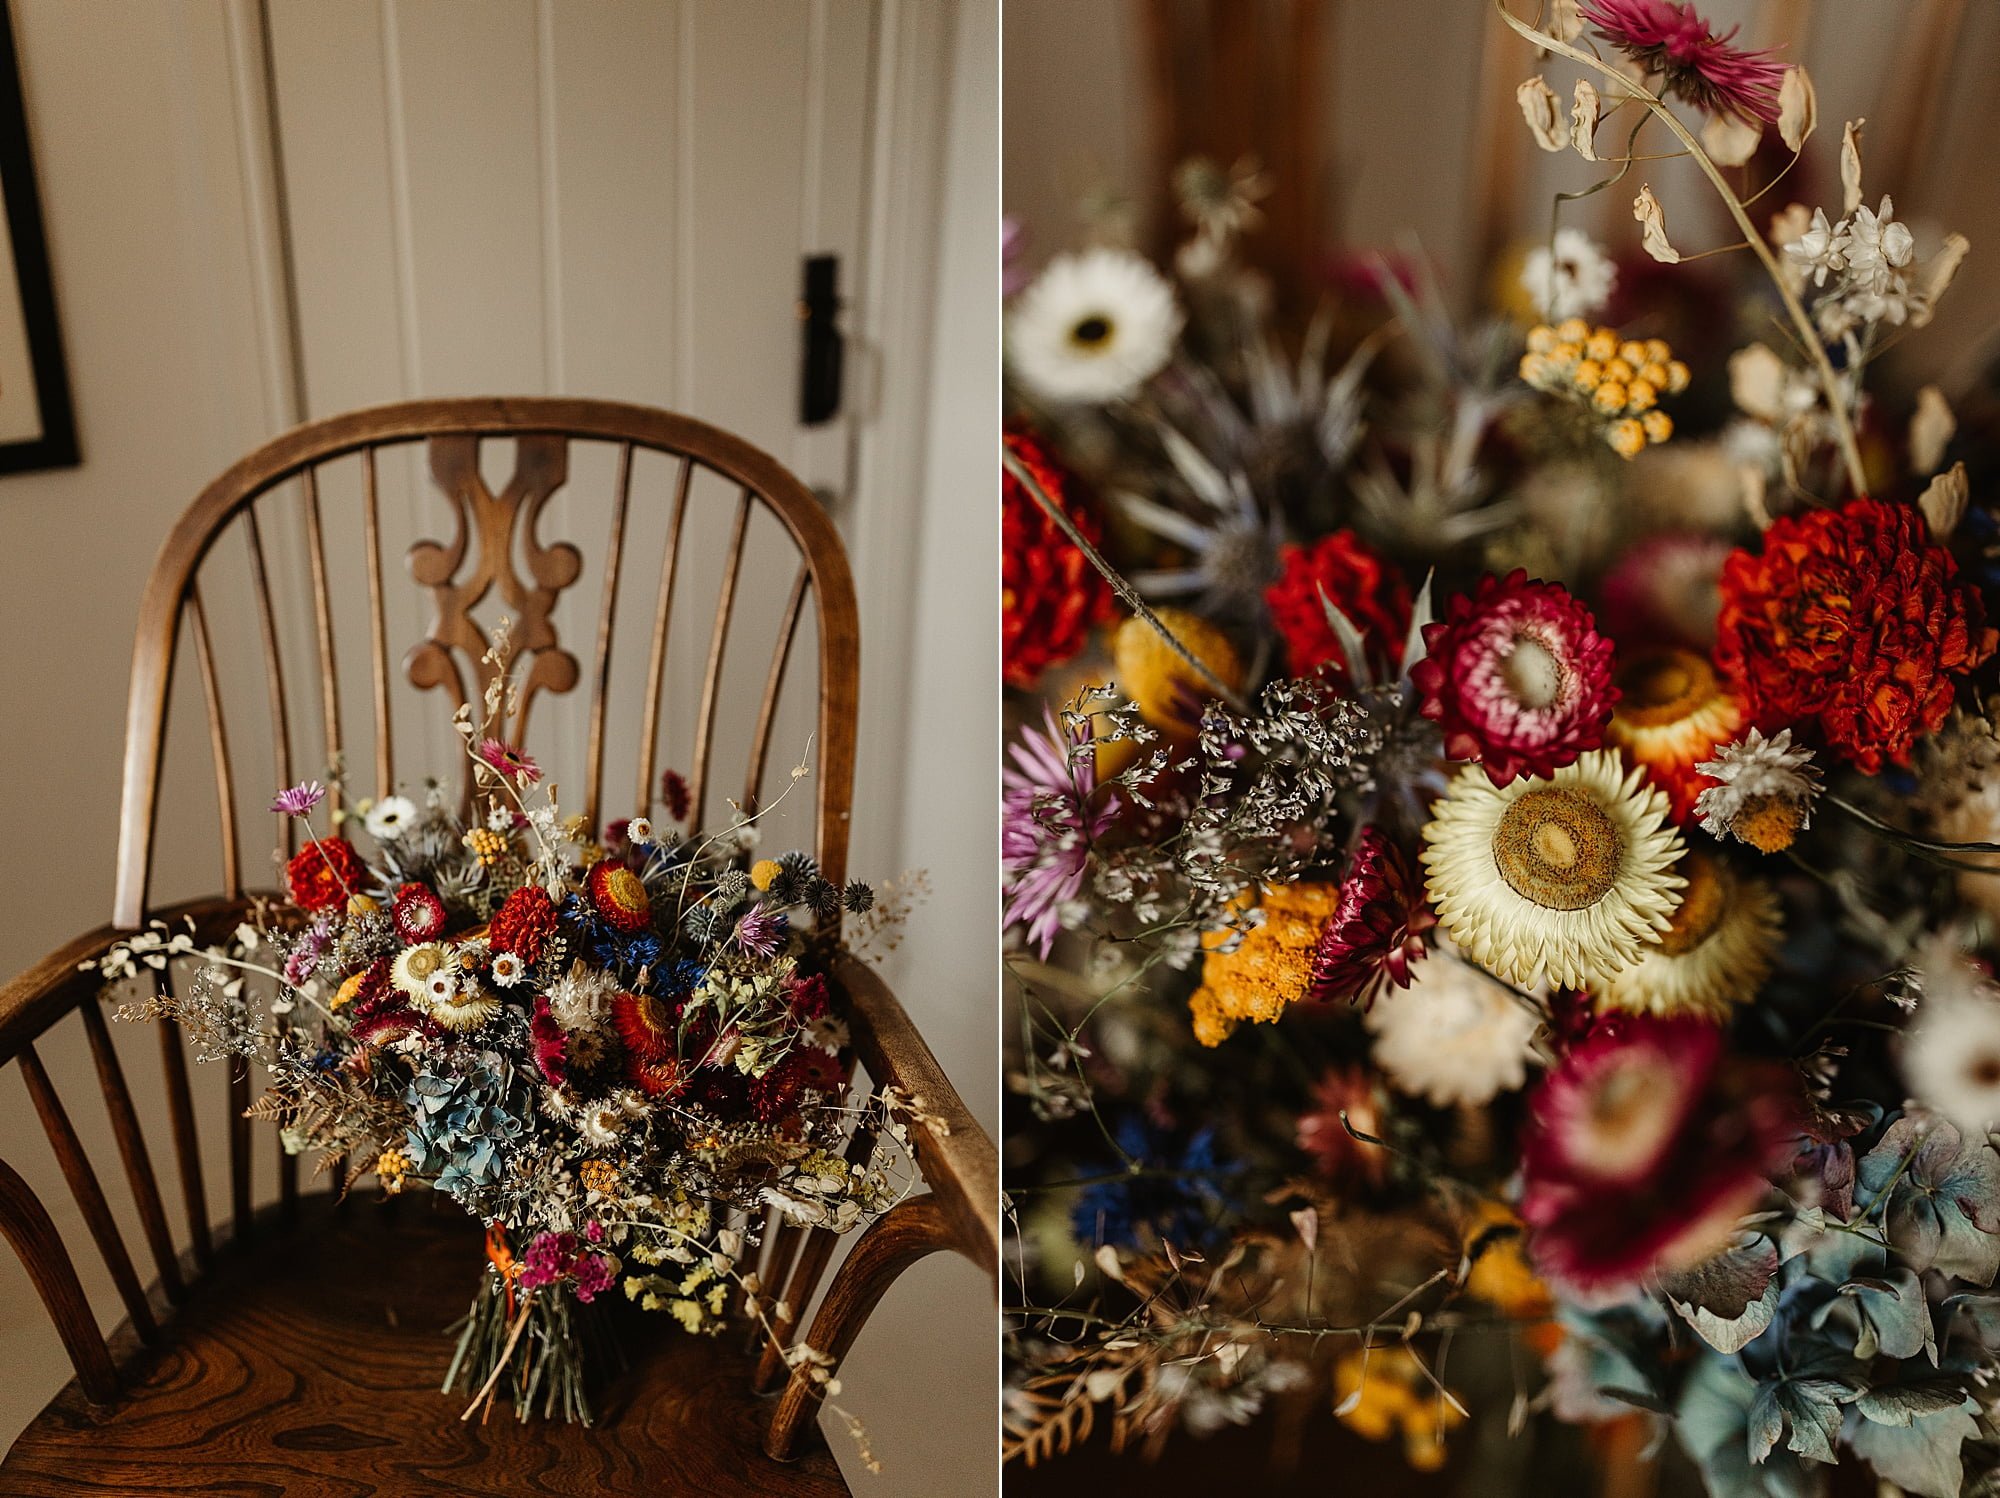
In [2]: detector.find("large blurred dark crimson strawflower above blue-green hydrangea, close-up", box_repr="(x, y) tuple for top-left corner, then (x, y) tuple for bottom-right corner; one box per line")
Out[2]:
(1520, 1016), (1806, 1294)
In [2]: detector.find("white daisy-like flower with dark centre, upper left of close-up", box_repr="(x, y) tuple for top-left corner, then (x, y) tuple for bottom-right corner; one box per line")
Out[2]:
(1006, 250), (1180, 404)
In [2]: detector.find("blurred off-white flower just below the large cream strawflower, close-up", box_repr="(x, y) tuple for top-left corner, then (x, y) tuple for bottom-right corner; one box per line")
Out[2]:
(1362, 952), (1538, 1108)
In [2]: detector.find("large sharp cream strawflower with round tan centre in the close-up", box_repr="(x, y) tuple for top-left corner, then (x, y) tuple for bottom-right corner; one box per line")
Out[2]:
(1424, 750), (1686, 988)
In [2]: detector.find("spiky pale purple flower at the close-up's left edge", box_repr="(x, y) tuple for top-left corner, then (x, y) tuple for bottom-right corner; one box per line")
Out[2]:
(1000, 710), (1120, 958)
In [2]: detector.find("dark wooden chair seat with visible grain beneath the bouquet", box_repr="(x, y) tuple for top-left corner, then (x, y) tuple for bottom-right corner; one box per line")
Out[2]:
(0, 1194), (848, 1498)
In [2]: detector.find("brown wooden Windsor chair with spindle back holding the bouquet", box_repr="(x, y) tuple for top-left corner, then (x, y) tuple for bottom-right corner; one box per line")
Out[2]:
(0, 398), (998, 1494)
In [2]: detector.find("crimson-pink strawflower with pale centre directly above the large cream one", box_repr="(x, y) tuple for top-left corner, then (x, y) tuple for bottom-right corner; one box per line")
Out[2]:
(1410, 568), (1618, 786)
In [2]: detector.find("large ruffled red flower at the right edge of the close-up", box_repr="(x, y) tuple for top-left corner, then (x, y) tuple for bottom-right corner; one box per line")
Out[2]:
(1716, 496), (2000, 774)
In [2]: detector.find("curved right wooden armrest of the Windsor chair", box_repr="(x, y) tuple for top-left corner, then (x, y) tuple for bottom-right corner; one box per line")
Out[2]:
(834, 954), (1000, 1282)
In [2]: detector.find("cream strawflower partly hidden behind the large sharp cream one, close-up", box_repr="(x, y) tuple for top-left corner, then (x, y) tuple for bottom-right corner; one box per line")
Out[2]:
(1590, 850), (1778, 1022)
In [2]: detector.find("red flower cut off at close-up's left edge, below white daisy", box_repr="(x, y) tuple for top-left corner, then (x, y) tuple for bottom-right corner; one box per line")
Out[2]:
(1000, 428), (1110, 688)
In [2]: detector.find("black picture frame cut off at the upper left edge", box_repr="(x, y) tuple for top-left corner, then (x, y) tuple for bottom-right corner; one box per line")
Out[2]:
(0, 0), (82, 474)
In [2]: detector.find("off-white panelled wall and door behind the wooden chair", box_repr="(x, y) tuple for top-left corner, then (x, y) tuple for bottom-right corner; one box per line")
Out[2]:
(0, 0), (998, 1498)
